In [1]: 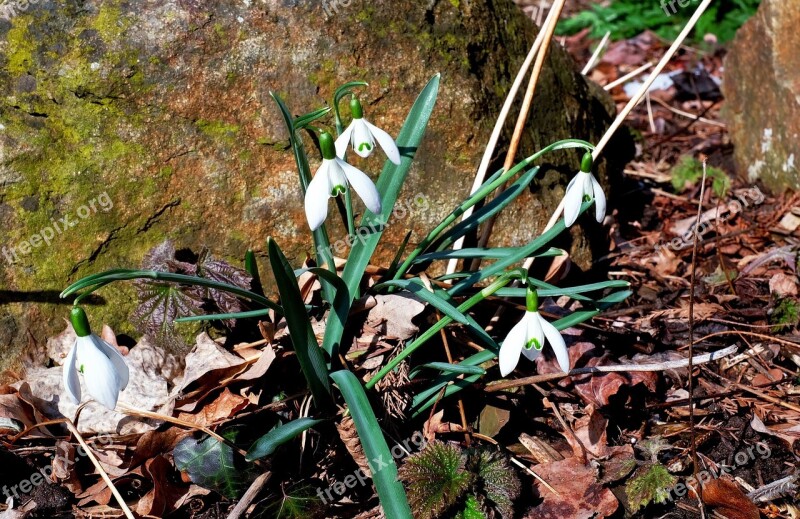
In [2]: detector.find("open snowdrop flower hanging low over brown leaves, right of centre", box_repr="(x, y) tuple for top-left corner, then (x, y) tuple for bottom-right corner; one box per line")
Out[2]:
(499, 286), (569, 377)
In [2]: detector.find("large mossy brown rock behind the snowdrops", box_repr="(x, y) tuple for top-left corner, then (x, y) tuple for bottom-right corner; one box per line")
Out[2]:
(0, 0), (613, 374)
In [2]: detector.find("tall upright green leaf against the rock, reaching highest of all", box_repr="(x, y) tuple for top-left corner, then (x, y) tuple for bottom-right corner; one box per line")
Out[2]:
(322, 74), (439, 360)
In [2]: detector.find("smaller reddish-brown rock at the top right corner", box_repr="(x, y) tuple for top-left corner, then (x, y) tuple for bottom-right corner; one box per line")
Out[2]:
(723, 0), (800, 192)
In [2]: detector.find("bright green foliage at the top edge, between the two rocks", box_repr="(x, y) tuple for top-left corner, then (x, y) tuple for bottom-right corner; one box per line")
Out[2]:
(557, 0), (760, 43)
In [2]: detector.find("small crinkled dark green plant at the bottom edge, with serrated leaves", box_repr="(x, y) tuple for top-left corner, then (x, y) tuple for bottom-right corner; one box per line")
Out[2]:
(399, 441), (520, 519)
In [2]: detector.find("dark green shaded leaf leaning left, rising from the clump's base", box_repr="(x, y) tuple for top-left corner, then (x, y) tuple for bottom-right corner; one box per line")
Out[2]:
(267, 238), (331, 407)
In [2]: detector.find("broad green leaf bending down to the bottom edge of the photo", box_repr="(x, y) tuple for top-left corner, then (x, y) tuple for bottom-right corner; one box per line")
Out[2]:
(331, 370), (411, 519)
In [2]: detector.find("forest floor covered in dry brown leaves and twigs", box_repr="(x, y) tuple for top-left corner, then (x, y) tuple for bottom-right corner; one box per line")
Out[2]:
(0, 3), (800, 519)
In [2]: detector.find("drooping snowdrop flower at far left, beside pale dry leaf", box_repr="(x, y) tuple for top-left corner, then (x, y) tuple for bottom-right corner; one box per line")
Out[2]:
(64, 307), (129, 410)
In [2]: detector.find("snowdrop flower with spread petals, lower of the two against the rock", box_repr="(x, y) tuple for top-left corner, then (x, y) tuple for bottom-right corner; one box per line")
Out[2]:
(305, 132), (381, 231)
